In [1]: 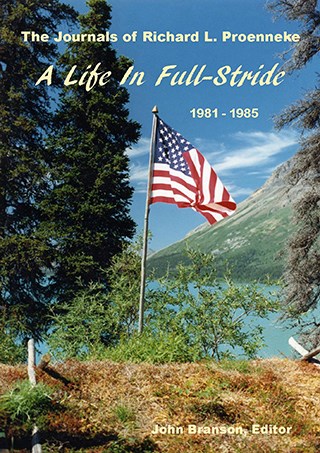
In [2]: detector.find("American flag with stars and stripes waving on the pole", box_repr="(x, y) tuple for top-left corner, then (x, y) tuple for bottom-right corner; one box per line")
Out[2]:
(150, 118), (236, 224)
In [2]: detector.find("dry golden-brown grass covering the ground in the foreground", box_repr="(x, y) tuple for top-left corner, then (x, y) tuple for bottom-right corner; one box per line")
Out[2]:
(0, 359), (320, 453)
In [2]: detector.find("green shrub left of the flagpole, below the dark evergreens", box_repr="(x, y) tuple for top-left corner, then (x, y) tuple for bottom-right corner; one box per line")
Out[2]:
(46, 239), (141, 359)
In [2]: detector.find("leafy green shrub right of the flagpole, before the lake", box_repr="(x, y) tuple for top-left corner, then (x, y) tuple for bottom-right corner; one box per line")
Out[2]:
(147, 249), (278, 360)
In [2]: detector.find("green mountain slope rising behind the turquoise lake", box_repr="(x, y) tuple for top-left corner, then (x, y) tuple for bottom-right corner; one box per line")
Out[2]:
(148, 158), (305, 281)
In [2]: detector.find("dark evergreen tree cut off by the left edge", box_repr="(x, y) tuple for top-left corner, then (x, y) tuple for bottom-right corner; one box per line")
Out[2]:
(0, 0), (75, 338)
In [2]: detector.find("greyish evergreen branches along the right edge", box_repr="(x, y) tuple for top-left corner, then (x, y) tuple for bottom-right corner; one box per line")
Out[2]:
(272, 0), (320, 344)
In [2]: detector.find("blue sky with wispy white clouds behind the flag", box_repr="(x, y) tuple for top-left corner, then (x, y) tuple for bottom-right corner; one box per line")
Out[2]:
(68, 0), (315, 250)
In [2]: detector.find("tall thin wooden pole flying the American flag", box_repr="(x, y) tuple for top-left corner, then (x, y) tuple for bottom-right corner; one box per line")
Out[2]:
(139, 105), (158, 333)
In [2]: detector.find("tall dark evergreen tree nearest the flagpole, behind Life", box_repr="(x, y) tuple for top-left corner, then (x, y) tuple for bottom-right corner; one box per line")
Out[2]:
(43, 0), (139, 300)
